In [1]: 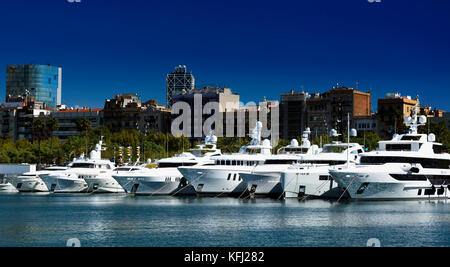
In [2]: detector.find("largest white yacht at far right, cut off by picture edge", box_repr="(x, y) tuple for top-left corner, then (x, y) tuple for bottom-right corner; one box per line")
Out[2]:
(330, 100), (450, 200)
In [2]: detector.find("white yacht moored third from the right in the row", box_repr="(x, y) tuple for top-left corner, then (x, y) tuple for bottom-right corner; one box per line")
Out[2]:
(239, 128), (321, 197)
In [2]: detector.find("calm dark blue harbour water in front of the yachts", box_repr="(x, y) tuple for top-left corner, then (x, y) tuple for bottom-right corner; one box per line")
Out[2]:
(0, 194), (450, 246)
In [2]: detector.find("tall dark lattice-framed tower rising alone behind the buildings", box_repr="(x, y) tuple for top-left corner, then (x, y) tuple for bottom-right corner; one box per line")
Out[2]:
(166, 65), (195, 109)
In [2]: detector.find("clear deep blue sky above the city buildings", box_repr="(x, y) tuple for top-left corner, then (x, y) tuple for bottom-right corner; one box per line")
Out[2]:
(0, 0), (450, 110)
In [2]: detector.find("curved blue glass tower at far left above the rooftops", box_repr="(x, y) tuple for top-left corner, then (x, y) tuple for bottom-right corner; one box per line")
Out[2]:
(6, 64), (62, 107)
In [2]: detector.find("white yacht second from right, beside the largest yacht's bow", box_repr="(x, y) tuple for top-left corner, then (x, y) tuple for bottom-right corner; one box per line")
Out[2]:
(281, 125), (364, 198)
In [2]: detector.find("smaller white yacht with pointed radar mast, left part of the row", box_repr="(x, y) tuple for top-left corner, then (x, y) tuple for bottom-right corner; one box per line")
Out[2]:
(43, 141), (125, 193)
